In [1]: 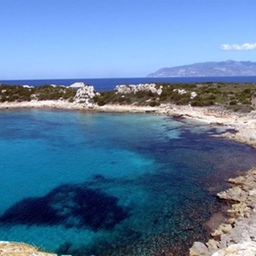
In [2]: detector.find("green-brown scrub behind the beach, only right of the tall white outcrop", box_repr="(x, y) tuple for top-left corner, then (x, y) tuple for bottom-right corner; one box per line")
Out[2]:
(95, 82), (256, 112)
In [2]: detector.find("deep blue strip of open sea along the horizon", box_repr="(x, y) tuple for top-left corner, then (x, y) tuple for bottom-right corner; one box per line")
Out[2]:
(0, 76), (256, 91)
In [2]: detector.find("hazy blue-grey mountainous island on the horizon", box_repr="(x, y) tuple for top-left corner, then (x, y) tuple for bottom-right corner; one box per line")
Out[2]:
(148, 60), (256, 77)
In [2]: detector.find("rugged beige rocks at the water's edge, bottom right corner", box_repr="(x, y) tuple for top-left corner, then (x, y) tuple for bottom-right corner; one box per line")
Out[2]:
(190, 168), (256, 256)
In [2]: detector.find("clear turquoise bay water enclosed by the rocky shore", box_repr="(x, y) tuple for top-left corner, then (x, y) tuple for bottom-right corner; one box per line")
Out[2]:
(0, 110), (256, 256)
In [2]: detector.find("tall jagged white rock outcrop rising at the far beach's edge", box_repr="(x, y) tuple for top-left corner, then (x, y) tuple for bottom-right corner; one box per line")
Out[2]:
(75, 85), (100, 108)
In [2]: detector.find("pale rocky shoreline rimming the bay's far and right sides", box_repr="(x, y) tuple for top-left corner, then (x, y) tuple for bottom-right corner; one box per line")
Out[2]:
(0, 100), (256, 256)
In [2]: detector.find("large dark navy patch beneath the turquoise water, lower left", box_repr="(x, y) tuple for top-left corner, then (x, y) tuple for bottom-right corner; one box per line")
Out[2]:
(0, 185), (129, 231)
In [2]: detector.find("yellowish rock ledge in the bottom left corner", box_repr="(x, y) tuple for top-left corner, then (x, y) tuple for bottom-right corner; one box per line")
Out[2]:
(0, 241), (57, 256)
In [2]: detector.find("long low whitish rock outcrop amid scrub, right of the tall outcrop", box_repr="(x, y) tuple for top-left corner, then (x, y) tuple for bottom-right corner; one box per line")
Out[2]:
(114, 83), (162, 95)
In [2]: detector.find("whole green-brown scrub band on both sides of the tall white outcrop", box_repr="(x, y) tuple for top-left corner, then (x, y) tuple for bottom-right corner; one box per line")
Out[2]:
(0, 82), (256, 112)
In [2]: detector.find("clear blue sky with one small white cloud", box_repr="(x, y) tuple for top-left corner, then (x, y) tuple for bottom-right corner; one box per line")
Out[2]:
(0, 0), (256, 80)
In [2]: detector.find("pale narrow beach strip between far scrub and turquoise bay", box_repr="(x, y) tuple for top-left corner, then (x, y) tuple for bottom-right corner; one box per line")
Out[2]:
(0, 100), (256, 147)
